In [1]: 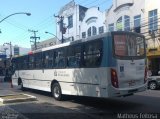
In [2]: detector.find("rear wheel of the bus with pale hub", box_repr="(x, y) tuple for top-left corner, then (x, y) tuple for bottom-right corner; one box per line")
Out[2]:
(51, 82), (62, 101)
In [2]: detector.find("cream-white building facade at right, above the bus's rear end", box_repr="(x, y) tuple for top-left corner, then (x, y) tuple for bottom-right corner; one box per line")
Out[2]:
(106, 0), (160, 48)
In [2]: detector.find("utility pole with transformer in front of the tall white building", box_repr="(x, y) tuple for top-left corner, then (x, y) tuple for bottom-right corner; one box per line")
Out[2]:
(54, 15), (66, 43)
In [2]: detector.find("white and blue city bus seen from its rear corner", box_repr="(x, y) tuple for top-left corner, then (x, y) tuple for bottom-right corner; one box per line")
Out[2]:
(12, 31), (146, 100)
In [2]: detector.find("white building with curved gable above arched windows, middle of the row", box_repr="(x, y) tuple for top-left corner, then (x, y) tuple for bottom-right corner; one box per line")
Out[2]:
(80, 7), (106, 38)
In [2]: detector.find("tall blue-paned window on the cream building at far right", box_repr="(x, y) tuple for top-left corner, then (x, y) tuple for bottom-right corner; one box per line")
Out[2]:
(149, 9), (158, 30)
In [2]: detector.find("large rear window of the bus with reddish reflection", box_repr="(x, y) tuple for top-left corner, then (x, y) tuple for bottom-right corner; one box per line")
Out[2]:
(112, 34), (145, 57)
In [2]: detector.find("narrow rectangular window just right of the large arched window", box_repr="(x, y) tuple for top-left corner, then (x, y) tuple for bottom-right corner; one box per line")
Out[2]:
(134, 15), (141, 33)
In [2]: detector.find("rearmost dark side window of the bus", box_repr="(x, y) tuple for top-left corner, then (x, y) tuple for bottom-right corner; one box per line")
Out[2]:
(83, 40), (102, 67)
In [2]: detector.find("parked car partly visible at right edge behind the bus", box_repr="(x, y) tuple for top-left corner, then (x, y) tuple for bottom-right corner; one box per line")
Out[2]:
(148, 76), (160, 90)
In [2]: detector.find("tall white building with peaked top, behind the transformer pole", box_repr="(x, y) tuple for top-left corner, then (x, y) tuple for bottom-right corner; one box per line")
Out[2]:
(56, 1), (80, 43)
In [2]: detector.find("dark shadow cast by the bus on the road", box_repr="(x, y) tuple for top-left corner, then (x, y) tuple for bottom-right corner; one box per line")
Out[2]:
(17, 89), (160, 113)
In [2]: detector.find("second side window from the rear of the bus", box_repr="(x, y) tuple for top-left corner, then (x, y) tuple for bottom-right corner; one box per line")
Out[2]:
(67, 45), (81, 67)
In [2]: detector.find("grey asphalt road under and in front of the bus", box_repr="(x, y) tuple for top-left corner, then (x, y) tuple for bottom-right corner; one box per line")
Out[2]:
(0, 82), (160, 119)
